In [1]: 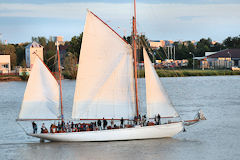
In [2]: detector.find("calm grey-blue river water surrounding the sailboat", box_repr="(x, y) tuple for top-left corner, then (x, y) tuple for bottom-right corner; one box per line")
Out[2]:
(0, 76), (240, 160)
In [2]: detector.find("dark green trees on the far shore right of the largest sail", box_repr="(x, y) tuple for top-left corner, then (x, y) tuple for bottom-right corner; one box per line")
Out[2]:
(124, 35), (240, 64)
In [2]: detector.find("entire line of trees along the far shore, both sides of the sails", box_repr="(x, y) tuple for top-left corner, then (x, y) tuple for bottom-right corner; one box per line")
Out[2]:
(0, 33), (240, 78)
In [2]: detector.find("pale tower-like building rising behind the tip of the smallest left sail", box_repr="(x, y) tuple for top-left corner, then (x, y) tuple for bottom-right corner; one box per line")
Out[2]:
(25, 42), (43, 68)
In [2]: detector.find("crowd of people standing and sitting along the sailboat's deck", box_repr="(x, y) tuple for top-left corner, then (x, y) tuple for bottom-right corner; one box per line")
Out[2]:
(32, 114), (161, 134)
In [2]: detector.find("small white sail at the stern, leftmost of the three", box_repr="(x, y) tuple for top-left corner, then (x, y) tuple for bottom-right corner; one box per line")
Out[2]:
(19, 56), (59, 119)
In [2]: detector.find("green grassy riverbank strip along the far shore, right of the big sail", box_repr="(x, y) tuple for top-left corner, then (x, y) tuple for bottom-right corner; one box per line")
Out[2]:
(138, 69), (240, 78)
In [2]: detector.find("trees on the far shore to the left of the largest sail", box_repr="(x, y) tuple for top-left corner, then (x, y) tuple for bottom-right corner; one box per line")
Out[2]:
(0, 33), (82, 78)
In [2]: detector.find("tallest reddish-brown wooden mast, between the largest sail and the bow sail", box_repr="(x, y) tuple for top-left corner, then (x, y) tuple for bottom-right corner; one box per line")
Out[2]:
(133, 0), (139, 117)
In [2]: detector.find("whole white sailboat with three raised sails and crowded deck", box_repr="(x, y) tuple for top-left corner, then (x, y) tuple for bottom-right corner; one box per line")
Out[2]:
(18, 1), (204, 141)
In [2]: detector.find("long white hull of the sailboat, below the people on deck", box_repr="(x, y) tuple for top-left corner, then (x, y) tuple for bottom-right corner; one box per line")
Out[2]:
(28, 122), (183, 142)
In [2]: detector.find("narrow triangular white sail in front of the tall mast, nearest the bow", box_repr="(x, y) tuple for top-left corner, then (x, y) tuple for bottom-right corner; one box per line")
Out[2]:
(143, 49), (178, 118)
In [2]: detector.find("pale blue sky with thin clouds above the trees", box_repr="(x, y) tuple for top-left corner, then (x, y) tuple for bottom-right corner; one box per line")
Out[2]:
(0, 0), (240, 43)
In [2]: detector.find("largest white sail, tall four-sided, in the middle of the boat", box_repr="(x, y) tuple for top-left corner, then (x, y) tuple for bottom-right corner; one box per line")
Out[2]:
(72, 11), (136, 119)
